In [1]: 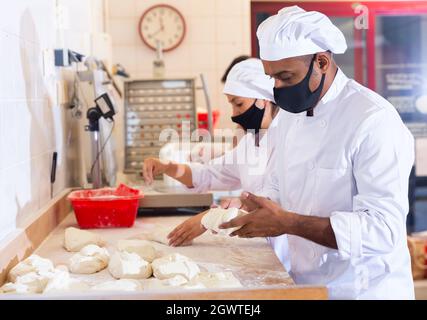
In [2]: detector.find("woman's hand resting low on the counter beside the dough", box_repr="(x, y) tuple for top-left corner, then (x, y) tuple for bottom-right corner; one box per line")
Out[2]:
(168, 211), (207, 247)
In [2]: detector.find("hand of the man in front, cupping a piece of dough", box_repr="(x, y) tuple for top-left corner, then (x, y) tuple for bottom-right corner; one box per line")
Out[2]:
(219, 193), (293, 238)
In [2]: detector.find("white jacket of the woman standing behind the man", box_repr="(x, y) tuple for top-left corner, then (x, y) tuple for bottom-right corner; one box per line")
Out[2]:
(188, 115), (291, 271)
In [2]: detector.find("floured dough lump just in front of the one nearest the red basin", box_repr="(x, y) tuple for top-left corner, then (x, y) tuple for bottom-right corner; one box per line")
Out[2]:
(69, 244), (110, 274)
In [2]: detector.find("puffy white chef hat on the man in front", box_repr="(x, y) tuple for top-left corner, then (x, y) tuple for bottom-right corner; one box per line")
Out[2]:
(257, 6), (347, 61)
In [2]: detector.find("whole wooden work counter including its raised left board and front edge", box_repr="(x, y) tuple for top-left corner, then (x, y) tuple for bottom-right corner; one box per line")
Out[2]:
(0, 195), (327, 300)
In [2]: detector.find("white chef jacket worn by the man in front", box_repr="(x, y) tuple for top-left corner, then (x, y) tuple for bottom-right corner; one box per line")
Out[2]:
(266, 70), (414, 299)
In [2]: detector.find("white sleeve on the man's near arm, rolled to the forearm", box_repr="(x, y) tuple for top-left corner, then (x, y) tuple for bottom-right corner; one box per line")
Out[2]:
(330, 109), (414, 259)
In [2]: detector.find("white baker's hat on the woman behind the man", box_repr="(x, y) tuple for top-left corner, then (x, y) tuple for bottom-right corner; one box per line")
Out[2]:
(223, 58), (274, 101)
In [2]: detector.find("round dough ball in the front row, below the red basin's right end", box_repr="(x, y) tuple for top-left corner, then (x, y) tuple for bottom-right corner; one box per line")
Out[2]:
(108, 251), (153, 279)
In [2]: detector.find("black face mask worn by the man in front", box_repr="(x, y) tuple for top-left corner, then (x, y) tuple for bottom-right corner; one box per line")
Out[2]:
(273, 55), (325, 113)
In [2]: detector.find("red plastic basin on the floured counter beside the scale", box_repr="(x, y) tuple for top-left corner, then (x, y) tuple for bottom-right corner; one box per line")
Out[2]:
(68, 184), (144, 229)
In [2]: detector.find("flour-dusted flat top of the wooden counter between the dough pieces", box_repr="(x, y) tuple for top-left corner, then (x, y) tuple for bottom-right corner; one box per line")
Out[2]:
(36, 214), (294, 288)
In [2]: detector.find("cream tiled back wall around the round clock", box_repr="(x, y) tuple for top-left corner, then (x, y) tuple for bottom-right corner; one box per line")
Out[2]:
(107, 0), (254, 127)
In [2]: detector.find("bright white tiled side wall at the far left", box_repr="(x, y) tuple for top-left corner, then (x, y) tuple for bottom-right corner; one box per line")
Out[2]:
(0, 0), (103, 241)
